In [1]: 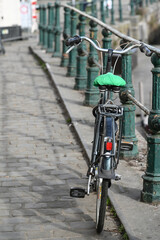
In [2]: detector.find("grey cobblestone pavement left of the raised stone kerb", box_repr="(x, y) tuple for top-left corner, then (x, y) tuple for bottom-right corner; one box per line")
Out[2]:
(0, 41), (121, 240)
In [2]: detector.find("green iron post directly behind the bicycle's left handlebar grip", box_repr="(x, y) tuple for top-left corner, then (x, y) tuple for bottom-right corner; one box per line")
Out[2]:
(67, 10), (77, 77)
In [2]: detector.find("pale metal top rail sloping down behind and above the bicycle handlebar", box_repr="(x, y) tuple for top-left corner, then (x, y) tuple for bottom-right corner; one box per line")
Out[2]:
(60, 3), (160, 54)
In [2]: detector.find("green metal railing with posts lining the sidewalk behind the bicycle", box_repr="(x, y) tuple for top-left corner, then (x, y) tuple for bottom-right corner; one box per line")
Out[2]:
(39, 1), (160, 202)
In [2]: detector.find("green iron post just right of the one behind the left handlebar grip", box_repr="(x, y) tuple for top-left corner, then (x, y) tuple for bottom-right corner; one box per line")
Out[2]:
(74, 15), (87, 90)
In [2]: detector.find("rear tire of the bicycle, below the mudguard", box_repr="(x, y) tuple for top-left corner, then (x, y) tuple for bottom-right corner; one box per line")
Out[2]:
(96, 178), (108, 233)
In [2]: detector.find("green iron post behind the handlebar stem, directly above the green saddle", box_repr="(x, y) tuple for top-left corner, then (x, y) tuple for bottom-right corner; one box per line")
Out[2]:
(102, 28), (112, 73)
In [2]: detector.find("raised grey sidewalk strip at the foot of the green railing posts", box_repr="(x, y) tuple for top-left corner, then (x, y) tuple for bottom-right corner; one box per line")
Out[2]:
(31, 38), (160, 240)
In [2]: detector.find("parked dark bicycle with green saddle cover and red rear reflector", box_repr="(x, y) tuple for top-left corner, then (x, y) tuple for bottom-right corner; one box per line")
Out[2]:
(66, 35), (151, 233)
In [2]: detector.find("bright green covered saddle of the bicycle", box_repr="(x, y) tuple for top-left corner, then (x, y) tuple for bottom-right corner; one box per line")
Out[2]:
(94, 72), (126, 87)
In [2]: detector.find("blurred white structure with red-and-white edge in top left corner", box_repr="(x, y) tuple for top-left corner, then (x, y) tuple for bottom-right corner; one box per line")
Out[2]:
(0, 0), (38, 39)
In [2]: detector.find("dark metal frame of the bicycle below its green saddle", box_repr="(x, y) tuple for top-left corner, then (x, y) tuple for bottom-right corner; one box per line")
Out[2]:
(87, 86), (123, 195)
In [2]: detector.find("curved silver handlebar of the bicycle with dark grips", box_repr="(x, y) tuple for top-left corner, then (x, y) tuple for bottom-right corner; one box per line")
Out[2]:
(66, 35), (152, 56)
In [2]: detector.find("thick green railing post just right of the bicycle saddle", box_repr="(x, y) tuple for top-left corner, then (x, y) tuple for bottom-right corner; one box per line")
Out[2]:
(120, 48), (138, 159)
